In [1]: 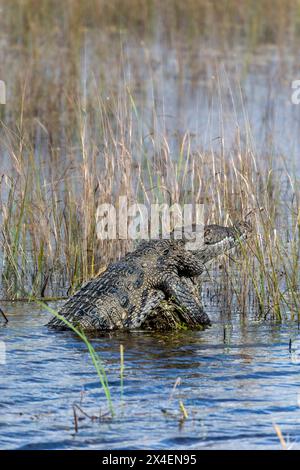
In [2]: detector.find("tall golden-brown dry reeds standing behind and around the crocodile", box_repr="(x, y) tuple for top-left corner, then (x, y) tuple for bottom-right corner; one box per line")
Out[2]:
(0, 0), (300, 319)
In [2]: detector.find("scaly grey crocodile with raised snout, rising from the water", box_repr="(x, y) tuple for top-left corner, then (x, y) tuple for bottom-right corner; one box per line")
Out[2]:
(48, 220), (252, 331)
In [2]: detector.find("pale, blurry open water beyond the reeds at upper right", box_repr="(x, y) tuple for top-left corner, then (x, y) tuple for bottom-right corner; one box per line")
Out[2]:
(81, 35), (300, 164)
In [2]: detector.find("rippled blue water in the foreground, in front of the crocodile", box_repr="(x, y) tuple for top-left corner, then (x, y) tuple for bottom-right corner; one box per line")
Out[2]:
(0, 303), (300, 449)
